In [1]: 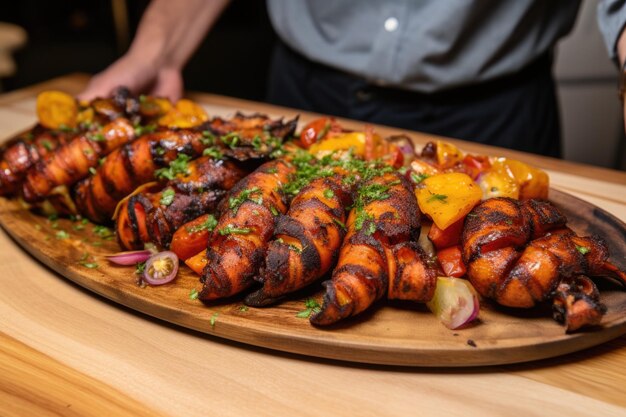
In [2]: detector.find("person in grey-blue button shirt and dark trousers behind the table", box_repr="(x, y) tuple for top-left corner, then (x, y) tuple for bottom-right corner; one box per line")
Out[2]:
(82, 0), (626, 156)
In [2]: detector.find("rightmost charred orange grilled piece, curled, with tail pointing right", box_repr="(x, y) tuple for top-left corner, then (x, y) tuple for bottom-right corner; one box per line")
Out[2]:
(462, 198), (626, 316)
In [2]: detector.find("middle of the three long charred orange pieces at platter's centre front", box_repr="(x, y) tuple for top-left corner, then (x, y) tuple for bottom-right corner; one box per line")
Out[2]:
(246, 176), (352, 307)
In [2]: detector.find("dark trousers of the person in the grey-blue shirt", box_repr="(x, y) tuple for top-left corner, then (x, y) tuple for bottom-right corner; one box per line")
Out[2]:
(267, 43), (561, 157)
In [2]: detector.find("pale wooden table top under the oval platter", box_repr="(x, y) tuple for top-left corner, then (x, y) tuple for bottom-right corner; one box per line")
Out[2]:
(0, 75), (626, 417)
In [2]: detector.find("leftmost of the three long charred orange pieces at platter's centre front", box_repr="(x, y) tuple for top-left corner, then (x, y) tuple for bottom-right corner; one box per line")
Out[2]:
(199, 160), (294, 301)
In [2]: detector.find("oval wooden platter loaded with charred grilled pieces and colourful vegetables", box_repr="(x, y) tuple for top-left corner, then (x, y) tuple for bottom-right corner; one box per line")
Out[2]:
(0, 88), (626, 367)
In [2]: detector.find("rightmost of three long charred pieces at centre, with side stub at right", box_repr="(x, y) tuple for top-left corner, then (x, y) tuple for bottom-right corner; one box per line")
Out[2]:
(310, 174), (435, 325)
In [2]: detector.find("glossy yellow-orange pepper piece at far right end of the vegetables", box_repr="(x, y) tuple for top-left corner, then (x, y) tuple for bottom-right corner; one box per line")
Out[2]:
(492, 158), (550, 200)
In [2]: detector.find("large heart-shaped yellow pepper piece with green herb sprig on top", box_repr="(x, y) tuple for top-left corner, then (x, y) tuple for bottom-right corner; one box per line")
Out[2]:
(415, 172), (482, 230)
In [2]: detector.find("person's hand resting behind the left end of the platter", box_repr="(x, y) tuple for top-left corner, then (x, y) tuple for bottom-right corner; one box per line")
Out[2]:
(78, 55), (183, 101)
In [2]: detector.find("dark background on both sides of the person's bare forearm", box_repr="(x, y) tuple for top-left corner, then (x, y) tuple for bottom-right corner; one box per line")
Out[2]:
(0, 0), (275, 100)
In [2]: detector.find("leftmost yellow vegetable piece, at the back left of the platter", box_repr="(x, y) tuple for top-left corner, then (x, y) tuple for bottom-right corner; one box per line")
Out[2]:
(37, 91), (78, 129)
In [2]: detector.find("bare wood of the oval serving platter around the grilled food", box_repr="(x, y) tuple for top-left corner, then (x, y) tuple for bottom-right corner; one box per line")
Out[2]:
(0, 190), (626, 367)
